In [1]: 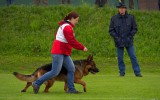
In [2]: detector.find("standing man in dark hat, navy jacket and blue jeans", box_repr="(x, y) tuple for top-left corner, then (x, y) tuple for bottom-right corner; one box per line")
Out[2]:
(109, 3), (142, 77)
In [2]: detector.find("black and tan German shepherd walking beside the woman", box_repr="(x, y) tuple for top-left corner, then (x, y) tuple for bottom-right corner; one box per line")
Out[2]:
(13, 55), (99, 92)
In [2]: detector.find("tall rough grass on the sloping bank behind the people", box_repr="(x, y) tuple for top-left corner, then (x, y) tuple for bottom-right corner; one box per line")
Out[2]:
(0, 5), (160, 57)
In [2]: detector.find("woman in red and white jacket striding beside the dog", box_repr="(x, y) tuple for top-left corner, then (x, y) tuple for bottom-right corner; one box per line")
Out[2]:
(32, 11), (87, 94)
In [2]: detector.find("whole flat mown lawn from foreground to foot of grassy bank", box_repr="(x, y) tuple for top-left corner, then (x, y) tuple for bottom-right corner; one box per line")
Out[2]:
(0, 56), (160, 100)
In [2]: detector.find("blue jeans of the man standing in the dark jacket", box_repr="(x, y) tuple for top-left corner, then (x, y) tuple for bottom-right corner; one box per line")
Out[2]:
(117, 46), (140, 75)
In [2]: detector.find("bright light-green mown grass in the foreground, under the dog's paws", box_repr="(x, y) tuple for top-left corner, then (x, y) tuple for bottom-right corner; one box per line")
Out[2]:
(0, 72), (160, 100)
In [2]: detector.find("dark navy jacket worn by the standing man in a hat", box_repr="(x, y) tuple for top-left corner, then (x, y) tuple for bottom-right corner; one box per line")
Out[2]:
(109, 12), (137, 47)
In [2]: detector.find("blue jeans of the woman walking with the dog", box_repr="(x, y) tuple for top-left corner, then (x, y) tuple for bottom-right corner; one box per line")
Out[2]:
(34, 54), (75, 91)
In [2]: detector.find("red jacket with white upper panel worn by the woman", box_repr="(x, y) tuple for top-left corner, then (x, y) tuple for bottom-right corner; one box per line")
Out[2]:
(51, 21), (84, 55)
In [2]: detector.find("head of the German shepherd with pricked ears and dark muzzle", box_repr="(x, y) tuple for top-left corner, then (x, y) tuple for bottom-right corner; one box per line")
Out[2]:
(85, 55), (99, 74)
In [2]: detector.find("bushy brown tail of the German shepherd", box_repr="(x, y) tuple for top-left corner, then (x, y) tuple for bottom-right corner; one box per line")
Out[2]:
(13, 72), (37, 82)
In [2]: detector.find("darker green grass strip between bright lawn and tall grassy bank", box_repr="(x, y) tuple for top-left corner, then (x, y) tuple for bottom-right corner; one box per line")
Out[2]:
(0, 55), (160, 74)
